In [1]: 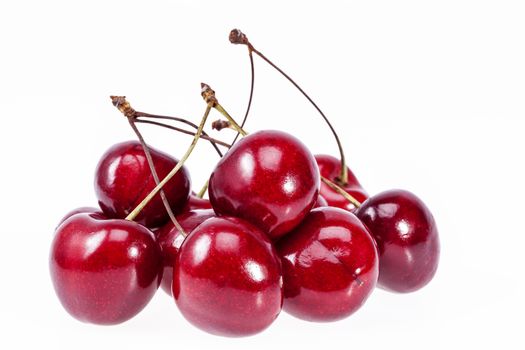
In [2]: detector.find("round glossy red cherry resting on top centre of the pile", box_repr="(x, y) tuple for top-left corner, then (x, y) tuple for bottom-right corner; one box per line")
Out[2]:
(209, 130), (320, 239)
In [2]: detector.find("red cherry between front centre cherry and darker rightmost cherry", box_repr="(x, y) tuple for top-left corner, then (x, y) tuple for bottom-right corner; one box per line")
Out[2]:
(277, 207), (379, 322)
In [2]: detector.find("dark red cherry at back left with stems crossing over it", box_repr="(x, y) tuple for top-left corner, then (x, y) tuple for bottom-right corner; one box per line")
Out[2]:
(95, 141), (190, 228)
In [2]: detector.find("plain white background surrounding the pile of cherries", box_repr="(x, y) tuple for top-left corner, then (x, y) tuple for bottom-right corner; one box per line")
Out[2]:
(0, 0), (525, 350)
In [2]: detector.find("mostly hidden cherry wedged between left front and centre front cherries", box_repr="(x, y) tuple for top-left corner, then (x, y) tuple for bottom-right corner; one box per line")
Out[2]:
(156, 209), (215, 295)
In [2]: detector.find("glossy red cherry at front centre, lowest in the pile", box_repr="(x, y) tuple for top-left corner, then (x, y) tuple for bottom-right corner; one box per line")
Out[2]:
(173, 217), (283, 337)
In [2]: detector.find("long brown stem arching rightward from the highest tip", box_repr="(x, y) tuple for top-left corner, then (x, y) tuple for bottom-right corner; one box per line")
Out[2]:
(230, 29), (348, 186)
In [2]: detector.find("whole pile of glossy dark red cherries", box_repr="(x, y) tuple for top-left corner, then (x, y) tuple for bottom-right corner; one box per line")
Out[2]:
(50, 32), (439, 336)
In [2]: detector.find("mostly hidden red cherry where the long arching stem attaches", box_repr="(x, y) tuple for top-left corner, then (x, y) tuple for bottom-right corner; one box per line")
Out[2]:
(315, 154), (368, 211)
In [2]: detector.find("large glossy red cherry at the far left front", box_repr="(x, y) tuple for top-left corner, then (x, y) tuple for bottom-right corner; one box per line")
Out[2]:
(49, 213), (162, 325)
